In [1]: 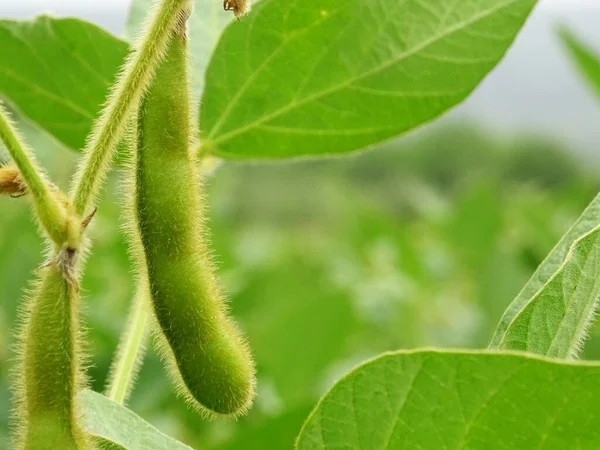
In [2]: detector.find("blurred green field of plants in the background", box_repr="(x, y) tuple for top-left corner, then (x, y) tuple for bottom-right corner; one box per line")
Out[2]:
(0, 117), (600, 449)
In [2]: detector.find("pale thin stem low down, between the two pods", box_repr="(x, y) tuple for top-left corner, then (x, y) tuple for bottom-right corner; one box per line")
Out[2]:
(107, 289), (149, 405)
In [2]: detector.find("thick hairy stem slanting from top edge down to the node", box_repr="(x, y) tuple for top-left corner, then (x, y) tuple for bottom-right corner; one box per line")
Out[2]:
(71, 0), (192, 215)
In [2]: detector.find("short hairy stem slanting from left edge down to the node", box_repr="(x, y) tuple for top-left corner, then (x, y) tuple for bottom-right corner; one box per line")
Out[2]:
(0, 103), (67, 246)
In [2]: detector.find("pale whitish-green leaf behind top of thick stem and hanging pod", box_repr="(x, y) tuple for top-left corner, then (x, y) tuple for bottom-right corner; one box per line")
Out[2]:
(127, 0), (233, 99)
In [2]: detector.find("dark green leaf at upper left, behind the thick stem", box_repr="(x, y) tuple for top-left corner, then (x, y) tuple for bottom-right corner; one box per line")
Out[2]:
(0, 16), (128, 149)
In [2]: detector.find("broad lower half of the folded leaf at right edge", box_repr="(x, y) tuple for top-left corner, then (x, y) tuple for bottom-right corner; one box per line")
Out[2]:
(498, 228), (600, 358)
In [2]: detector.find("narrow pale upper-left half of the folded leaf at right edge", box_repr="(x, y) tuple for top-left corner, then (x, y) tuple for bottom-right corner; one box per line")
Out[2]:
(490, 195), (600, 349)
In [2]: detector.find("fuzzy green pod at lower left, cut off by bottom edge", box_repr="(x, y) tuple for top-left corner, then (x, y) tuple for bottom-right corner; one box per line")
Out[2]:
(13, 264), (88, 450)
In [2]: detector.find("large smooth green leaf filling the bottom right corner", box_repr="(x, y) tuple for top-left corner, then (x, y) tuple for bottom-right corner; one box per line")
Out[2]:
(296, 351), (600, 450)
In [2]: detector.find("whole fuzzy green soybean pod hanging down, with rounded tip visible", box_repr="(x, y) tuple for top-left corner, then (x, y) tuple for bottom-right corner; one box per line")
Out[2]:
(134, 22), (255, 415)
